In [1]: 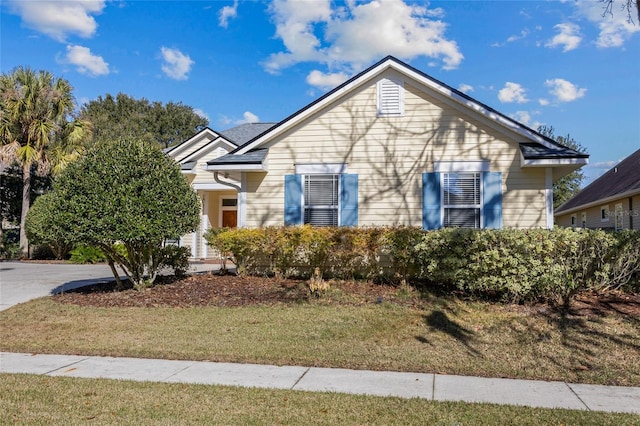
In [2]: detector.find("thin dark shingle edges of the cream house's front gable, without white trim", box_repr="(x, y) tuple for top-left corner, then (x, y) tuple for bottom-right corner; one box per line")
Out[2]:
(228, 56), (589, 159)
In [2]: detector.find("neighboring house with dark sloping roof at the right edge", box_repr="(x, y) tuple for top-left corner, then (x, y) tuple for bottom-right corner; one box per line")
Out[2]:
(555, 149), (640, 229)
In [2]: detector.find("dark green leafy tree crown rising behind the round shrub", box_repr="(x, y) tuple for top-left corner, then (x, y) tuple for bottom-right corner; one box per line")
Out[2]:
(82, 93), (208, 148)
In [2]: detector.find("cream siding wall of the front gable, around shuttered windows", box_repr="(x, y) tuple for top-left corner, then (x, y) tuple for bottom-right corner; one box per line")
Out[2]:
(247, 75), (547, 228)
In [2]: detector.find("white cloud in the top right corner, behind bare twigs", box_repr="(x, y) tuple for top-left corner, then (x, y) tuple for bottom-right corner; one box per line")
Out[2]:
(574, 1), (640, 48)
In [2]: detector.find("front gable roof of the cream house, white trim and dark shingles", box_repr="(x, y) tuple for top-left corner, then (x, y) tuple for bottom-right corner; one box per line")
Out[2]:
(228, 56), (589, 165)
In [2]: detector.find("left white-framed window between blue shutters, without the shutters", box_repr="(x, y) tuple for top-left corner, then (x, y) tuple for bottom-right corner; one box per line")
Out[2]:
(302, 174), (340, 226)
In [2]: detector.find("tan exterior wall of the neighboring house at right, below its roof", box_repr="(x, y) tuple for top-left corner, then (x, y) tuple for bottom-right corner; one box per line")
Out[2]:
(556, 195), (640, 230)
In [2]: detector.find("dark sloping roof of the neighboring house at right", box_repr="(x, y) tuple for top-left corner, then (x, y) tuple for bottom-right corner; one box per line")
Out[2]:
(556, 149), (640, 214)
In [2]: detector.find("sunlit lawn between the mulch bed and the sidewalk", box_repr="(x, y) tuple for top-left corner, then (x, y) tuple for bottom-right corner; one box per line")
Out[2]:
(0, 292), (640, 386)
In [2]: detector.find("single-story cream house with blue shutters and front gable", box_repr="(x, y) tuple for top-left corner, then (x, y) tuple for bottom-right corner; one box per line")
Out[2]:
(168, 56), (588, 257)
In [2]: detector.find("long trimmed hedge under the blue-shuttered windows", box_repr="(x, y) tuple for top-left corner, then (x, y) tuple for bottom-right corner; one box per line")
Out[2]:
(205, 226), (640, 304)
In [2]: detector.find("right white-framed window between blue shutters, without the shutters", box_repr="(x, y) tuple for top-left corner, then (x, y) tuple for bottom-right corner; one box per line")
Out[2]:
(442, 172), (482, 228)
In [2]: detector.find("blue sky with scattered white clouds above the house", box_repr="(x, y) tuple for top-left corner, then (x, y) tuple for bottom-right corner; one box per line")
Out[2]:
(0, 0), (640, 185)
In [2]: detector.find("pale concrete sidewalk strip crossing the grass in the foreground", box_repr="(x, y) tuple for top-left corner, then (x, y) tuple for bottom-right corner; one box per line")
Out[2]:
(0, 352), (640, 414)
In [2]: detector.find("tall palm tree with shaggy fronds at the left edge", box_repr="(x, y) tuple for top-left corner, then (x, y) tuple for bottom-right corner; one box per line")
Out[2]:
(0, 67), (90, 258)
